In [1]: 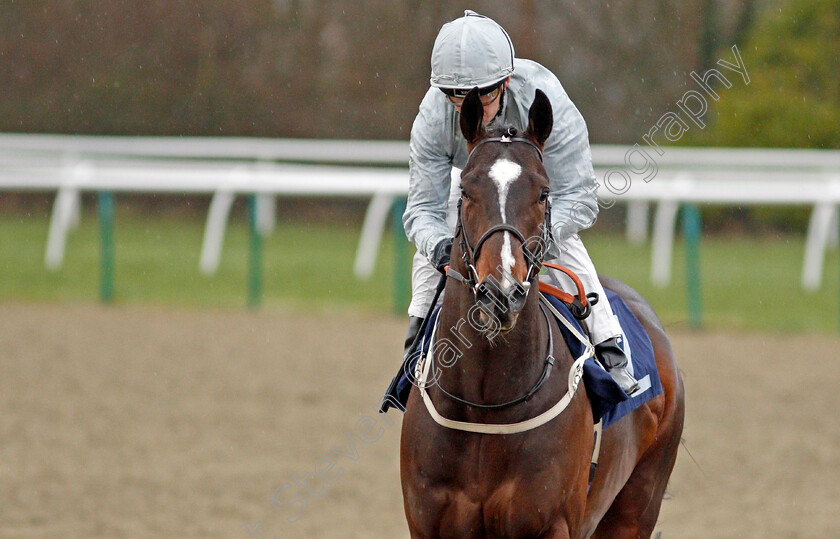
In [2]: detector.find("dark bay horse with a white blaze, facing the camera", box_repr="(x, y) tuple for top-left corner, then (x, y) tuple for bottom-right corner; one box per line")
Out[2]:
(400, 86), (684, 539)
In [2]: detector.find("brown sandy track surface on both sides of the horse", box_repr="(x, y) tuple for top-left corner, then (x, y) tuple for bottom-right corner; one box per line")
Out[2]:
(0, 304), (840, 538)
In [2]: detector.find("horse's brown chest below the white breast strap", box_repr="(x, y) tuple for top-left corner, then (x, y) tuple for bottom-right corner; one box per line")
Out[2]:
(402, 378), (591, 538)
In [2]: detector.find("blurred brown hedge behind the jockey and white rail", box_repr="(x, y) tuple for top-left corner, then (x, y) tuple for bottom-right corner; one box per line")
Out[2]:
(0, 0), (750, 143)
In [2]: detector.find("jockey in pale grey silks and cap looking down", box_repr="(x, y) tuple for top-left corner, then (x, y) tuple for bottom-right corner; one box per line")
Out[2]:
(403, 10), (638, 394)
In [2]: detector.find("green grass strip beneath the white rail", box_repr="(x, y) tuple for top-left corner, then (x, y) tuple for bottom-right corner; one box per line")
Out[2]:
(0, 210), (840, 331)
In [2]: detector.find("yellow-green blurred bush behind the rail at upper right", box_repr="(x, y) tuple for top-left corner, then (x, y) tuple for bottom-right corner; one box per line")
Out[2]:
(690, 0), (840, 148)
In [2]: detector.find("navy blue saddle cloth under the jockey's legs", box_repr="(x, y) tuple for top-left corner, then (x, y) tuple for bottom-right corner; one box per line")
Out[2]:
(381, 290), (662, 427)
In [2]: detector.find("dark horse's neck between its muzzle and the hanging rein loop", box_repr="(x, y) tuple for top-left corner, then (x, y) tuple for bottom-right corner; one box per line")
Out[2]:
(436, 286), (548, 400)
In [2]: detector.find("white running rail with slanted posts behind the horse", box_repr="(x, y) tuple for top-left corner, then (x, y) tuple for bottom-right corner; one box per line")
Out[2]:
(0, 134), (840, 290)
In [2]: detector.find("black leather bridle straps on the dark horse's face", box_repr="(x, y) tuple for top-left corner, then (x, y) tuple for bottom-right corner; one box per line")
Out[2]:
(447, 127), (552, 295)
